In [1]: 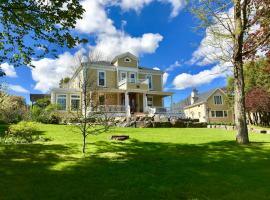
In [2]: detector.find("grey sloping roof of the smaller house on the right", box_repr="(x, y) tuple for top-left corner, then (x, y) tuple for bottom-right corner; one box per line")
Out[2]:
(175, 88), (226, 108)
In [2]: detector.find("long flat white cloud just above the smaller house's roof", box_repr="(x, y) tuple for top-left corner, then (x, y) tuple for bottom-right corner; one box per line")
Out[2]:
(173, 63), (231, 90)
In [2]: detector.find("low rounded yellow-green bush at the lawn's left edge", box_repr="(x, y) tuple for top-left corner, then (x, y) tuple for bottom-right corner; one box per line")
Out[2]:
(1, 121), (48, 144)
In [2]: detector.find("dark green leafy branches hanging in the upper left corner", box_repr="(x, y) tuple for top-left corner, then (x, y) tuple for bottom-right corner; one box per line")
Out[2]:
(0, 0), (86, 76)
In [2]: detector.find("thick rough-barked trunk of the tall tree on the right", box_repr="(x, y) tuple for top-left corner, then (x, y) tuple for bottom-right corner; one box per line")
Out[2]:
(233, 0), (249, 144)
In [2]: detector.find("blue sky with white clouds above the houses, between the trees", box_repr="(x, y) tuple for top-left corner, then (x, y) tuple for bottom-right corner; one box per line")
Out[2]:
(0, 0), (232, 105)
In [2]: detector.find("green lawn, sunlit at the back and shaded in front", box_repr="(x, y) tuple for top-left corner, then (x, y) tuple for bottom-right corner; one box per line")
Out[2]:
(0, 125), (270, 200)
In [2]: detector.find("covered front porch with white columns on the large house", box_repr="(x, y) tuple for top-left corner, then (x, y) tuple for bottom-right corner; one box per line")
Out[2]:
(89, 89), (176, 117)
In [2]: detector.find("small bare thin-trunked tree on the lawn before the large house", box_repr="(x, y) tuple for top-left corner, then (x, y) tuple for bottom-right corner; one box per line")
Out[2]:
(71, 52), (113, 153)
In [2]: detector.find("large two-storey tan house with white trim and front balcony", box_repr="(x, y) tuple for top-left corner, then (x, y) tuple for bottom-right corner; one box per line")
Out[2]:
(51, 52), (182, 116)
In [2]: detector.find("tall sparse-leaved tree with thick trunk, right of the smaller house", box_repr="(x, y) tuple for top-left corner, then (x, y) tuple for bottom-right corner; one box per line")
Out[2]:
(192, 0), (270, 144)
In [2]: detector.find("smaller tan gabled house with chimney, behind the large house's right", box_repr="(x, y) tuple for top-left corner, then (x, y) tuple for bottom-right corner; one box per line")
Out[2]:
(173, 88), (234, 123)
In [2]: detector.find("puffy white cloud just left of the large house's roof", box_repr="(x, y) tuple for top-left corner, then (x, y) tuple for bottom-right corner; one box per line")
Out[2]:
(32, 51), (81, 93)
